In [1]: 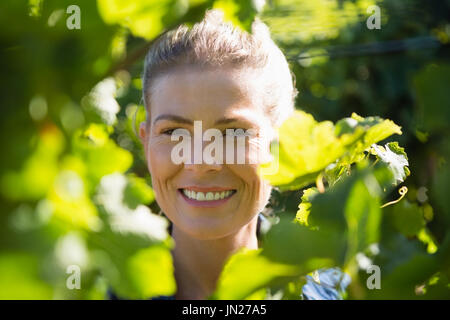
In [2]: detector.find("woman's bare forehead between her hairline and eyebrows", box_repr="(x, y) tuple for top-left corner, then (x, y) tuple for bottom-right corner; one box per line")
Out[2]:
(150, 68), (264, 125)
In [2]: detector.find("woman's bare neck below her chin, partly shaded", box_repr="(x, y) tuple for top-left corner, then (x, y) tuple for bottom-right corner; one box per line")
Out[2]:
(172, 215), (258, 300)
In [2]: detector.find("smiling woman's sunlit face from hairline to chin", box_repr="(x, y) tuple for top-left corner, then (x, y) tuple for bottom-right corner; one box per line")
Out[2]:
(141, 67), (272, 239)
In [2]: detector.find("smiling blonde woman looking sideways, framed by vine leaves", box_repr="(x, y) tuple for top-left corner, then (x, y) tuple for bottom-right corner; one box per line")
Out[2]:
(136, 11), (296, 299)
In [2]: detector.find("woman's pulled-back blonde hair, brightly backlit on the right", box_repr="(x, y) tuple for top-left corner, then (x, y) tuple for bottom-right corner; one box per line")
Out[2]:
(142, 10), (297, 127)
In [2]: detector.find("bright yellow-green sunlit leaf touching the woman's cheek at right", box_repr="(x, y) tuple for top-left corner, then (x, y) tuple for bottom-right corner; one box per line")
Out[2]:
(260, 110), (401, 190)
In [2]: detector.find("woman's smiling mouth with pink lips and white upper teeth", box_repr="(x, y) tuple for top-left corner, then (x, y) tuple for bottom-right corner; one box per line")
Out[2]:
(178, 187), (237, 208)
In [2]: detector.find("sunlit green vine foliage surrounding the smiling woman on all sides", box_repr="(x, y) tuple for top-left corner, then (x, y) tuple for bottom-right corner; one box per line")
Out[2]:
(0, 0), (450, 299)
